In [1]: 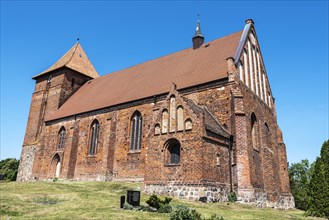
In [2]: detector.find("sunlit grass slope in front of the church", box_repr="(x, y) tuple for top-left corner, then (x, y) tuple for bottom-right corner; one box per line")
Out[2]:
(0, 181), (319, 220)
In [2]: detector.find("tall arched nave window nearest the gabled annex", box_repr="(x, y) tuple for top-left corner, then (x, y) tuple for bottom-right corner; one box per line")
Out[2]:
(130, 111), (142, 150)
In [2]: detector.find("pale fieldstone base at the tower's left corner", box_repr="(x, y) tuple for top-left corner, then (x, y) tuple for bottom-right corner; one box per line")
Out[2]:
(17, 145), (37, 182)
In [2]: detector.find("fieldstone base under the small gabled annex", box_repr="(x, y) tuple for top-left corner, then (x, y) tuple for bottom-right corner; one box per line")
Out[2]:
(144, 185), (229, 202)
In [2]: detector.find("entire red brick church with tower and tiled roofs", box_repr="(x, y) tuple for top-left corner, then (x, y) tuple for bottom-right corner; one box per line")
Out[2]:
(18, 19), (294, 208)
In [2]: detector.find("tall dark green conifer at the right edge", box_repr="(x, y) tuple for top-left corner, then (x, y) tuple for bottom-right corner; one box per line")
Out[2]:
(307, 140), (329, 218)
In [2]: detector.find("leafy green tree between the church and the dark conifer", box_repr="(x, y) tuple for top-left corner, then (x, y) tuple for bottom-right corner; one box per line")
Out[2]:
(289, 159), (314, 210)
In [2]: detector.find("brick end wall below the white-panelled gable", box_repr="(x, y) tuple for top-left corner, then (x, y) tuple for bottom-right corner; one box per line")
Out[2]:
(239, 79), (287, 201)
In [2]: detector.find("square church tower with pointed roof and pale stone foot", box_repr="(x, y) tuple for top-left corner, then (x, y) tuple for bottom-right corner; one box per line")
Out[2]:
(17, 42), (99, 181)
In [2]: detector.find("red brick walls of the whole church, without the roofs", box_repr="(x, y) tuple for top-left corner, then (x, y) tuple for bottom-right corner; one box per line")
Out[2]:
(18, 19), (294, 208)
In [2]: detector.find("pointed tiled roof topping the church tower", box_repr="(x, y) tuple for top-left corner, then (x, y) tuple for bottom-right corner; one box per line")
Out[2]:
(33, 42), (99, 79)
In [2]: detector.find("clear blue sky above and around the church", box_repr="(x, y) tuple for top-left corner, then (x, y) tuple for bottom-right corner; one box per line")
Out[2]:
(0, 1), (329, 163)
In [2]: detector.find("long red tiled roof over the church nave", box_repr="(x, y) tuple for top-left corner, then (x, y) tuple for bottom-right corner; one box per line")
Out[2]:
(47, 31), (242, 121)
